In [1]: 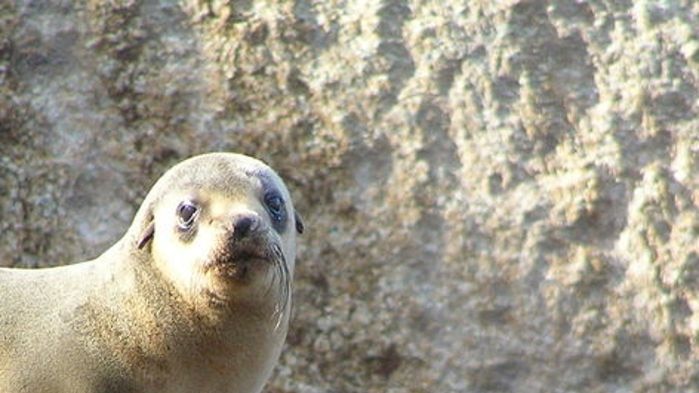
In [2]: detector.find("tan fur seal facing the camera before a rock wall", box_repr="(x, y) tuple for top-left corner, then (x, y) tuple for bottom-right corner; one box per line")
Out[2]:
(0, 153), (303, 393)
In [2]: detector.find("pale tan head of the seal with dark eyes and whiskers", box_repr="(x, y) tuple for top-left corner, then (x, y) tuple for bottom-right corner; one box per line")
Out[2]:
(133, 153), (303, 312)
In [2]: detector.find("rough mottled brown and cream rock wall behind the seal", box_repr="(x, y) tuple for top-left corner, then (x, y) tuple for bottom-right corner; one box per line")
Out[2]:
(0, 0), (699, 393)
